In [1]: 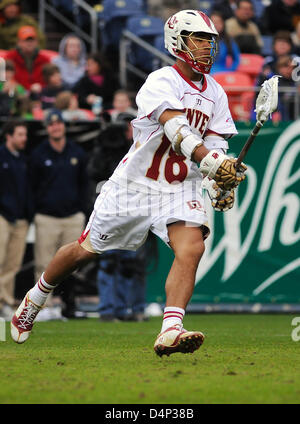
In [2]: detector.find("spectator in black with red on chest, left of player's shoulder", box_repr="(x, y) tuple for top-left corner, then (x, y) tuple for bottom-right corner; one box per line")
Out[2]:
(73, 53), (119, 110)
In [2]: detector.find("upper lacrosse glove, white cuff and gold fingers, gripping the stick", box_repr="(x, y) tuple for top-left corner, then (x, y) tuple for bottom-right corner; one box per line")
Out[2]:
(200, 150), (247, 191)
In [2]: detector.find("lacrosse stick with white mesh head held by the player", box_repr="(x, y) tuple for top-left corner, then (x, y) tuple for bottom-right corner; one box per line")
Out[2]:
(235, 75), (279, 169)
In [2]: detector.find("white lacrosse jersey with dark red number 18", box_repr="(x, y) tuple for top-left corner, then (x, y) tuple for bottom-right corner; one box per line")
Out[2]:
(110, 65), (237, 193)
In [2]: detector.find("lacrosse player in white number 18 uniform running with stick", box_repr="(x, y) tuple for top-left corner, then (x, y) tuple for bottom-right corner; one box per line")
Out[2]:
(11, 10), (246, 356)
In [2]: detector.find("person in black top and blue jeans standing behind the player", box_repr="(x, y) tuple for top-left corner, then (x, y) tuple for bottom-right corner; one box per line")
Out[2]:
(88, 113), (146, 321)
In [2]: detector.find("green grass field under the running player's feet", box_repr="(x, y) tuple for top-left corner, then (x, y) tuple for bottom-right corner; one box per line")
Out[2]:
(0, 314), (300, 404)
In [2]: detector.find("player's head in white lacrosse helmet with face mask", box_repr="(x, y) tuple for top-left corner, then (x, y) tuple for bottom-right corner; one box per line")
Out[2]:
(165, 10), (219, 74)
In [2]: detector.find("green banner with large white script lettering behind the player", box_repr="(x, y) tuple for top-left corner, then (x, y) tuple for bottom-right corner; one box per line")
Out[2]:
(147, 120), (300, 303)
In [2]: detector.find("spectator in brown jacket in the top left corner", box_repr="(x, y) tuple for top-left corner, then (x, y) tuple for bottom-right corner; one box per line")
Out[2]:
(0, 0), (45, 50)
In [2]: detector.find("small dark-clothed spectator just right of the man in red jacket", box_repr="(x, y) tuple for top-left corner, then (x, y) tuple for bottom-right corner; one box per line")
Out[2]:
(40, 63), (67, 109)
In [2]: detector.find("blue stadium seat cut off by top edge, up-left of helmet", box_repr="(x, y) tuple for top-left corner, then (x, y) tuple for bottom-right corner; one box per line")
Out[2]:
(98, 0), (144, 50)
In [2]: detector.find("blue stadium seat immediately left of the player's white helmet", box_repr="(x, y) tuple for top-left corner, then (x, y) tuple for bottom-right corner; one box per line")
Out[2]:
(126, 15), (167, 72)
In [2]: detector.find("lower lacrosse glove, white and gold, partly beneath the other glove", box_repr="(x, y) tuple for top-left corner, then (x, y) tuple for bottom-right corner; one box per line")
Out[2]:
(202, 177), (234, 212)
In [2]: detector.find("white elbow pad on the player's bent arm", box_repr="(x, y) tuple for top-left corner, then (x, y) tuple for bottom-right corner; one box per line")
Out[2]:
(164, 115), (203, 160)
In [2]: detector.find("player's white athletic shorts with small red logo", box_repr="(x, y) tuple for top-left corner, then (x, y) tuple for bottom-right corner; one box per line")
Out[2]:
(78, 180), (209, 253)
